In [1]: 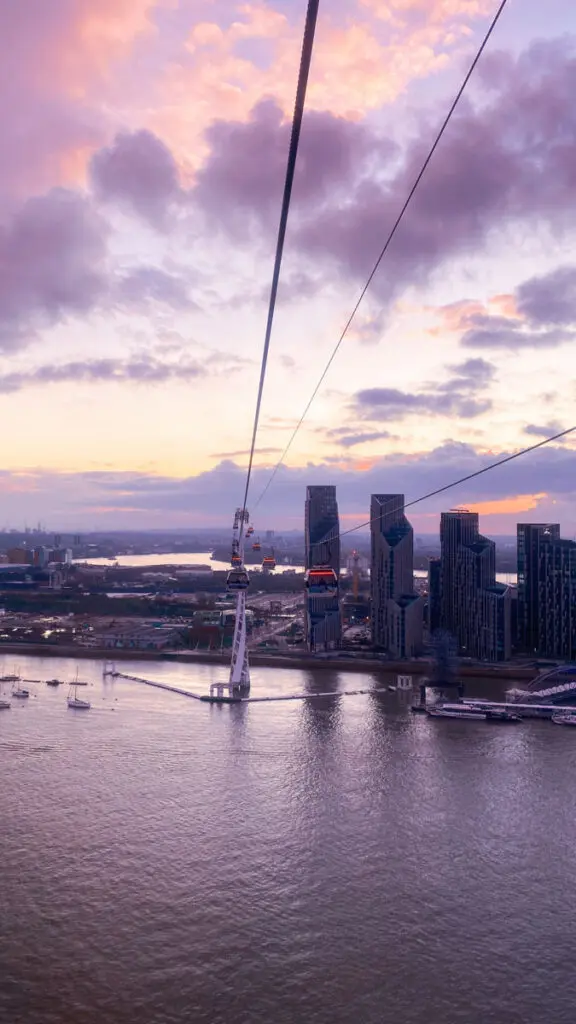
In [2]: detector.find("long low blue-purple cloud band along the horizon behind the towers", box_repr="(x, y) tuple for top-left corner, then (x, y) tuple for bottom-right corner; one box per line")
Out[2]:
(5, 441), (576, 544)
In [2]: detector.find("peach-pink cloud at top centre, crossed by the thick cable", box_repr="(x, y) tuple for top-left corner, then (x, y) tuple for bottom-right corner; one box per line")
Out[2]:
(149, 0), (490, 174)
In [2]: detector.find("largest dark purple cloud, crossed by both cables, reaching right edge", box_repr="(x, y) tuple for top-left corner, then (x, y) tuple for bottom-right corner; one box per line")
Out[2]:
(186, 39), (576, 300)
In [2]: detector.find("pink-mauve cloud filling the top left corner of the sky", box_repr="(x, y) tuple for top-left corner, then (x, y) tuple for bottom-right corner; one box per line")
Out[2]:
(0, 0), (164, 201)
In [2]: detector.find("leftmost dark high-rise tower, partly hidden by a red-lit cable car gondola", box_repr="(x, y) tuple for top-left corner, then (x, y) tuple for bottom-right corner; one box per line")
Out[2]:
(304, 484), (342, 650)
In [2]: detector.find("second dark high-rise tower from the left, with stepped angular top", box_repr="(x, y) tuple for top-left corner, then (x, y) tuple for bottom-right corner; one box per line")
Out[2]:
(370, 495), (423, 657)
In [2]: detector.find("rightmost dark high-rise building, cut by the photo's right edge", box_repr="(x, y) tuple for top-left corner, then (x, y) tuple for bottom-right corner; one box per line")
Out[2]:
(517, 522), (576, 659)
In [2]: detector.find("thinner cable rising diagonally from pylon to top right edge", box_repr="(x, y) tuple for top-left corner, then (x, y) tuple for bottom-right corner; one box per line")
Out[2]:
(254, 0), (507, 508)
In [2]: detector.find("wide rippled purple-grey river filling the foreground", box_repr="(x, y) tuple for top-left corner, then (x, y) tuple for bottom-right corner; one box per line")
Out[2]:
(0, 657), (576, 1024)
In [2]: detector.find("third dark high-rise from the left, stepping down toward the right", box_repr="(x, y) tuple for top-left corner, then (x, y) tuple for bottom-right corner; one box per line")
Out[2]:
(440, 509), (511, 662)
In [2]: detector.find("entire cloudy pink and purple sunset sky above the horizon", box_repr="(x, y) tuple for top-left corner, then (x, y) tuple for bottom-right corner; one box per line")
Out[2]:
(0, 0), (576, 537)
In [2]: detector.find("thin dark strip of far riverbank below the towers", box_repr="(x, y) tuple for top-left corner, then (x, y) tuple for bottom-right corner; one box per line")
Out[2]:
(0, 643), (538, 681)
